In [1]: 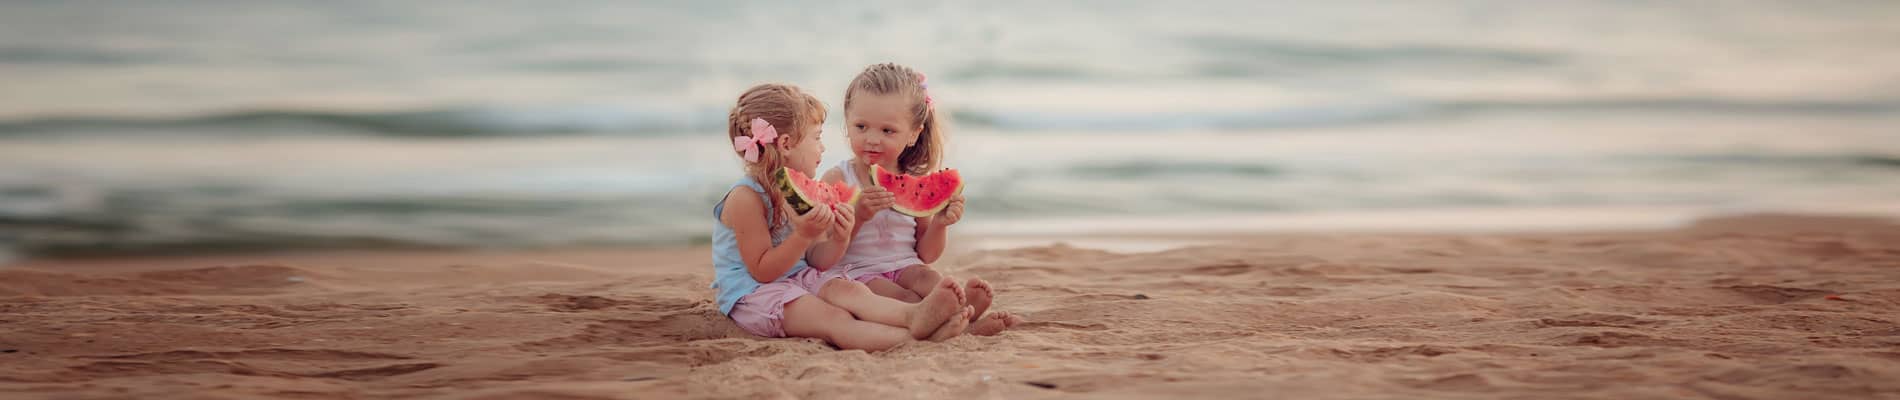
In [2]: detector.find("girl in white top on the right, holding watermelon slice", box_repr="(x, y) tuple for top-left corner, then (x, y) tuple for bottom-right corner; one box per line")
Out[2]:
(811, 63), (1022, 336)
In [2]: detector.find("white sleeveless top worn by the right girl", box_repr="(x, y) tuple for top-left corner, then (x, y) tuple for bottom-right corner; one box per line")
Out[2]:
(830, 159), (923, 279)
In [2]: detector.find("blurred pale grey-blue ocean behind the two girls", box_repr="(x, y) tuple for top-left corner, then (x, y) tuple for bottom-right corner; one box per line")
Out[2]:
(0, 0), (1900, 260)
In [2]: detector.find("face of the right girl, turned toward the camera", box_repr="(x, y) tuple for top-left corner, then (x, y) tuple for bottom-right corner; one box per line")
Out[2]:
(844, 91), (923, 171)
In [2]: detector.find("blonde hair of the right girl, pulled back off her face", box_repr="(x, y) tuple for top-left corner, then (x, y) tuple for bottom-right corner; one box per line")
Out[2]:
(844, 63), (948, 174)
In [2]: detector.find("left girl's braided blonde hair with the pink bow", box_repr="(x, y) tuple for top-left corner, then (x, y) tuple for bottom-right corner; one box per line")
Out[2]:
(726, 83), (825, 233)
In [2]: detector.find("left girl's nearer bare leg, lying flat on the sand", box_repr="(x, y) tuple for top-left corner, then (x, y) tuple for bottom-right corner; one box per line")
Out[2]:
(785, 294), (912, 351)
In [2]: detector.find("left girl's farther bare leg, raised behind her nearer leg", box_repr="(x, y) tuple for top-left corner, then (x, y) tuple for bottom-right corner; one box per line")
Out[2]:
(819, 279), (963, 339)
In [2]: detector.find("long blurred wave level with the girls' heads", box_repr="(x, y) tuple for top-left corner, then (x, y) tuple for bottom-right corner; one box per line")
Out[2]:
(0, 97), (1900, 138)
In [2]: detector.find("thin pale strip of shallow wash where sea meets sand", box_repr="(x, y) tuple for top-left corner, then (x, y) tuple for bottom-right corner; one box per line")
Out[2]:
(0, 205), (1900, 269)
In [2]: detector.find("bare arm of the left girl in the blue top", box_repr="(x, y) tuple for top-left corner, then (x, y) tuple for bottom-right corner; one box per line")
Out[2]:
(720, 188), (830, 282)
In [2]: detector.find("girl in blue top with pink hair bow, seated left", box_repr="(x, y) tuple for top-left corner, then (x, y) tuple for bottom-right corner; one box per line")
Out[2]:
(713, 83), (975, 351)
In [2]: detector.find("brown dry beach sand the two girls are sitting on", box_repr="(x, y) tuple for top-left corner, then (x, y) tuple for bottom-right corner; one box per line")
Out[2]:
(0, 216), (1900, 398)
